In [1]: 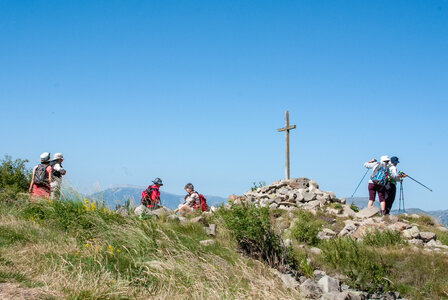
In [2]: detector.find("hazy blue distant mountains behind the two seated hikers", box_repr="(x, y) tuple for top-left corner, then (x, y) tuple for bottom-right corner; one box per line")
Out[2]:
(89, 185), (227, 209)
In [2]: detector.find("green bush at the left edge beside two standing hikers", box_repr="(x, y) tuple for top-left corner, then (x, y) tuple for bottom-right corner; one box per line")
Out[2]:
(0, 155), (32, 199)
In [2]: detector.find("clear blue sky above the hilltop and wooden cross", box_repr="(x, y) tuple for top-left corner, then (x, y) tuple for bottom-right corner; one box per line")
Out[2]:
(0, 0), (448, 209)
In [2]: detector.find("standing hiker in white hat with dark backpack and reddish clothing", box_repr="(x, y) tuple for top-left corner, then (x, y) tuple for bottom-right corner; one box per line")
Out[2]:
(28, 152), (52, 202)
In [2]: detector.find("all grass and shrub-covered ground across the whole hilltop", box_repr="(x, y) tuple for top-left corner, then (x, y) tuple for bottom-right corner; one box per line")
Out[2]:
(0, 193), (448, 299)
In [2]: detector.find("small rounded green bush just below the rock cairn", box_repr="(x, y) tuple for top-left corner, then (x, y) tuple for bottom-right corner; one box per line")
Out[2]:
(291, 210), (322, 246)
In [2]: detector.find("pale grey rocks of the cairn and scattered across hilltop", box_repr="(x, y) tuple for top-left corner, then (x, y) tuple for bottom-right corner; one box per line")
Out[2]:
(128, 178), (448, 299)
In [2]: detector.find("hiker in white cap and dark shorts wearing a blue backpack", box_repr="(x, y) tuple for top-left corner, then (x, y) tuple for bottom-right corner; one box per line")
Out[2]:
(364, 155), (390, 215)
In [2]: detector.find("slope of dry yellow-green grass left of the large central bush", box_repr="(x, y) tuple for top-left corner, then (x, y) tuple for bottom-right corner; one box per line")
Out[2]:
(0, 193), (298, 299)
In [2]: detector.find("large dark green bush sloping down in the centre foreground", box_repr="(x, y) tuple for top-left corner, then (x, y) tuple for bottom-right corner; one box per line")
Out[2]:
(218, 204), (296, 270)
